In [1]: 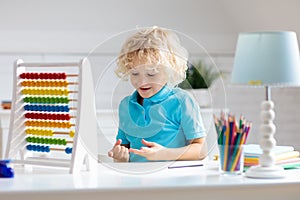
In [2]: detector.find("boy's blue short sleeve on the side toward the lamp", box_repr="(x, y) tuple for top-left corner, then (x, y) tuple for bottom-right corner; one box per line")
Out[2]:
(181, 94), (206, 140)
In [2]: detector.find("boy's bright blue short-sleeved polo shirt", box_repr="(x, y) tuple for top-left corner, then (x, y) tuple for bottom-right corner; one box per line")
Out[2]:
(117, 86), (206, 162)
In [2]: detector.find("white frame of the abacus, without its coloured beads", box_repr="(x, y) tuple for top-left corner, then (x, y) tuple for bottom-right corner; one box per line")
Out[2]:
(5, 58), (97, 173)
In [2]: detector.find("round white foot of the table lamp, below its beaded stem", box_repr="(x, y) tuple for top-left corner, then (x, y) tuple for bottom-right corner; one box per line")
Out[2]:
(245, 165), (285, 179)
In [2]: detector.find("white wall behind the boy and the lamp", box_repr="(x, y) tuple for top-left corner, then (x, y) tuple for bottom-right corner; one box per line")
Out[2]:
(0, 0), (300, 150)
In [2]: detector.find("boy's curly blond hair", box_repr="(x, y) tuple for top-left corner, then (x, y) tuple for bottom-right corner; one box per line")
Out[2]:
(115, 27), (188, 86)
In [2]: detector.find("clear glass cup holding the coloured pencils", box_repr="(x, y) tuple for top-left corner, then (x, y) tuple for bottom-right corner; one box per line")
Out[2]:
(219, 145), (244, 175)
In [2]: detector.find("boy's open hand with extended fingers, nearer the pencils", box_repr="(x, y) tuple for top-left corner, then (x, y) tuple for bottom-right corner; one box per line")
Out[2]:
(129, 139), (166, 160)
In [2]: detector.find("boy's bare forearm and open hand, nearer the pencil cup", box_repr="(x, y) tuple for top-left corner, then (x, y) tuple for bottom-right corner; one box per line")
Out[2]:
(129, 138), (207, 161)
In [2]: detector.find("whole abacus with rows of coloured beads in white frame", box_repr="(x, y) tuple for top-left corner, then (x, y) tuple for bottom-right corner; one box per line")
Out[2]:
(5, 58), (97, 173)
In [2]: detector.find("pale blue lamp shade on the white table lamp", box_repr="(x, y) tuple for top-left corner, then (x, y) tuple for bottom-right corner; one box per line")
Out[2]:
(231, 31), (300, 86)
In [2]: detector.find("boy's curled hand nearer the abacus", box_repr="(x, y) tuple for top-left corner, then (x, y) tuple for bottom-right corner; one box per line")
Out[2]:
(108, 139), (129, 162)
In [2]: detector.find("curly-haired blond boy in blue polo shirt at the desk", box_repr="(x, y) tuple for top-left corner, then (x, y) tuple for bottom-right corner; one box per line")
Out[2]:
(108, 27), (207, 162)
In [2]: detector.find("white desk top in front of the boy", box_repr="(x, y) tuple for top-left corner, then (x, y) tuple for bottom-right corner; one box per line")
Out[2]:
(0, 163), (300, 200)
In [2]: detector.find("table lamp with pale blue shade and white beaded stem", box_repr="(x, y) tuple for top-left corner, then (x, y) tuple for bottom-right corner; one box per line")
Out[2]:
(231, 31), (300, 178)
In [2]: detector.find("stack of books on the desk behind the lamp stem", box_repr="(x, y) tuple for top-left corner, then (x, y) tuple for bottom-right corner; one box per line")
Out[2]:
(244, 144), (300, 169)
